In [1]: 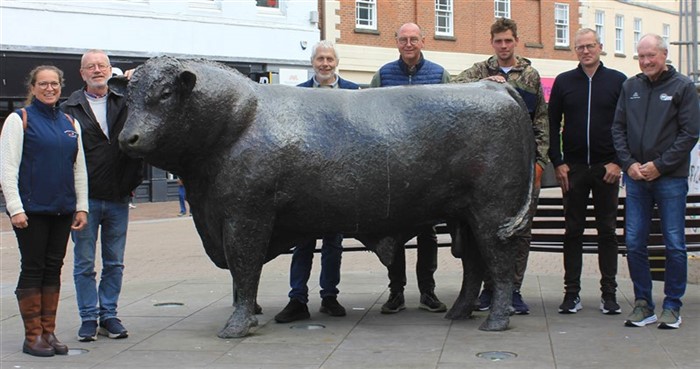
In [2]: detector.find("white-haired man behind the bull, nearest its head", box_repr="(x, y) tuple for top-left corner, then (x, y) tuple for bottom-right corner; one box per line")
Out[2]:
(275, 40), (360, 323)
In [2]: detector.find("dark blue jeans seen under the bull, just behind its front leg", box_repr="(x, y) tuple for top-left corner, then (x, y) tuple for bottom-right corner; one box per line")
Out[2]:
(289, 233), (343, 304)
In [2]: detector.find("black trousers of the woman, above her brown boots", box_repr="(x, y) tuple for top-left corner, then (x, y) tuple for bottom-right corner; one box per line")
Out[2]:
(13, 214), (73, 289)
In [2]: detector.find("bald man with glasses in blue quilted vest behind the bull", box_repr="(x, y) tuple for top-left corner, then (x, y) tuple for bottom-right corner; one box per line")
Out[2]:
(370, 23), (450, 314)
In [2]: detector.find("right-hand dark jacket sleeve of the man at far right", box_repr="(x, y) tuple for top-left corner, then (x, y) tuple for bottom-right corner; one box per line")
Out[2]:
(654, 82), (700, 175)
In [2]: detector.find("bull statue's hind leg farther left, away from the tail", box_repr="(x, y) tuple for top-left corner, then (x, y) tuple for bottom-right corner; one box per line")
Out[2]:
(445, 222), (483, 320)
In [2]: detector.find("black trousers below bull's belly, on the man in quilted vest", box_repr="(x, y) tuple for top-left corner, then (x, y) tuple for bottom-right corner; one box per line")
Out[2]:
(387, 227), (437, 294)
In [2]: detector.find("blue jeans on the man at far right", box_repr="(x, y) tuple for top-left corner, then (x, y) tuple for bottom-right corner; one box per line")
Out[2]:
(625, 175), (688, 310)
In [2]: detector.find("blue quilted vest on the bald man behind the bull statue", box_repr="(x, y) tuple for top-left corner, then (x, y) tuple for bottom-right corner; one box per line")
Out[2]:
(372, 55), (449, 87)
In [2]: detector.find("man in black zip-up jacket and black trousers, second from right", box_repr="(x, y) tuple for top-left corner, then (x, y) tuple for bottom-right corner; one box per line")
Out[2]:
(549, 28), (627, 314)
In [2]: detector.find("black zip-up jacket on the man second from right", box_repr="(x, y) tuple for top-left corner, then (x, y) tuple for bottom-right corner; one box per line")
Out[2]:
(549, 63), (627, 167)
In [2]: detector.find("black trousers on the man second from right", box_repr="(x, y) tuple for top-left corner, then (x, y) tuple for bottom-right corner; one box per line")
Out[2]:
(564, 164), (619, 294)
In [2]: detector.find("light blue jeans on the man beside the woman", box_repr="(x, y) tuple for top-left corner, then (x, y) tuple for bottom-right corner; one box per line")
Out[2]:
(72, 198), (129, 321)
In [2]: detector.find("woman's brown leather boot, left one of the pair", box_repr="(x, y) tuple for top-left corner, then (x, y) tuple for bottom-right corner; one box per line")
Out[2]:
(15, 288), (56, 357)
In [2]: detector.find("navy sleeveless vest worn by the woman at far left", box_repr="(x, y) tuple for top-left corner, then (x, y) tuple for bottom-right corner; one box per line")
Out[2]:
(16, 99), (80, 214)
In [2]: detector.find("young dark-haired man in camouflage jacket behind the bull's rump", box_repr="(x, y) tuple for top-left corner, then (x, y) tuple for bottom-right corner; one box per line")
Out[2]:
(452, 18), (549, 314)
